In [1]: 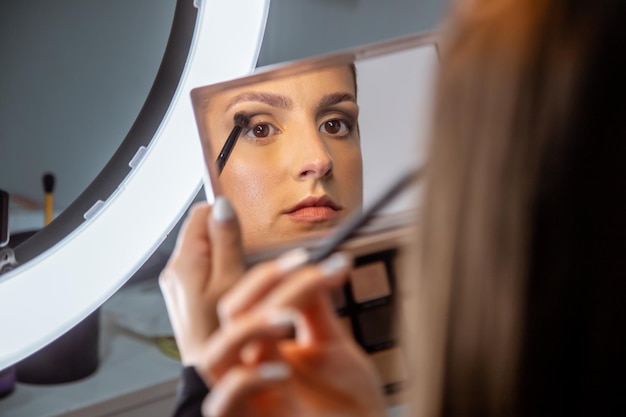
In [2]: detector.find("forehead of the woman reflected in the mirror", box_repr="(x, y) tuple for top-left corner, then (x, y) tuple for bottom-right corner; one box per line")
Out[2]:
(208, 65), (356, 111)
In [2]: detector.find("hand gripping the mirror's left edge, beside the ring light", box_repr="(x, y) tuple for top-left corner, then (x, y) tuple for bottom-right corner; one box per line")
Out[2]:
(159, 197), (244, 365)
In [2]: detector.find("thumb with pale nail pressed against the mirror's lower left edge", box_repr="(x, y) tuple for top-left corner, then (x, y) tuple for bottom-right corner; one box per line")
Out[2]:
(209, 196), (245, 295)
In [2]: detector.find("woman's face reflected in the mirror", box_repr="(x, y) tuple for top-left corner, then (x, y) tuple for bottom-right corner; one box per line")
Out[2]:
(207, 66), (363, 247)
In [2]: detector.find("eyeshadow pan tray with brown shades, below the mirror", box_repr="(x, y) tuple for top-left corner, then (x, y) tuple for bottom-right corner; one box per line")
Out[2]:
(246, 210), (416, 405)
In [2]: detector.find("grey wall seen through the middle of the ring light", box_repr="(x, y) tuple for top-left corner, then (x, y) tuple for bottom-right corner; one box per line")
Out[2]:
(0, 0), (176, 213)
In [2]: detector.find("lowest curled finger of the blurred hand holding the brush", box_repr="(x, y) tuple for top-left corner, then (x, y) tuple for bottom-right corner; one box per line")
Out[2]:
(202, 362), (291, 417)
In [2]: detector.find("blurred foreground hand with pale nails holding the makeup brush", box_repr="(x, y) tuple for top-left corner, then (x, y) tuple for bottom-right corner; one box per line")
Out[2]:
(197, 251), (385, 417)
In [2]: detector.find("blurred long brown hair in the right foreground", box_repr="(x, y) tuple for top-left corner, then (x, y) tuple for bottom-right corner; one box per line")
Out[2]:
(411, 0), (626, 417)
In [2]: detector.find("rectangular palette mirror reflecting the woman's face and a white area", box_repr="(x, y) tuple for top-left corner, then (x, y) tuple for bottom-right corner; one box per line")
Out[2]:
(191, 34), (438, 253)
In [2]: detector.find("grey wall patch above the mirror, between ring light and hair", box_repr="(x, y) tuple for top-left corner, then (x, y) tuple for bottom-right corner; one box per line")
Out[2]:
(259, 0), (447, 65)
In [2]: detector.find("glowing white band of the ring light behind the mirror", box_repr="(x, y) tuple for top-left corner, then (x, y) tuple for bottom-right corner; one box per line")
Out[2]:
(0, 0), (269, 369)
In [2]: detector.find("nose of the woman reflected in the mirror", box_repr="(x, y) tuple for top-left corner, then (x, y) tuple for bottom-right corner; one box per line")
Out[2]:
(293, 132), (334, 180)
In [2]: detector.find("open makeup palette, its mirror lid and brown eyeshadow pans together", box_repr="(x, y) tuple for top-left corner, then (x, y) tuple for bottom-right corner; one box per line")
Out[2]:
(191, 34), (438, 405)
